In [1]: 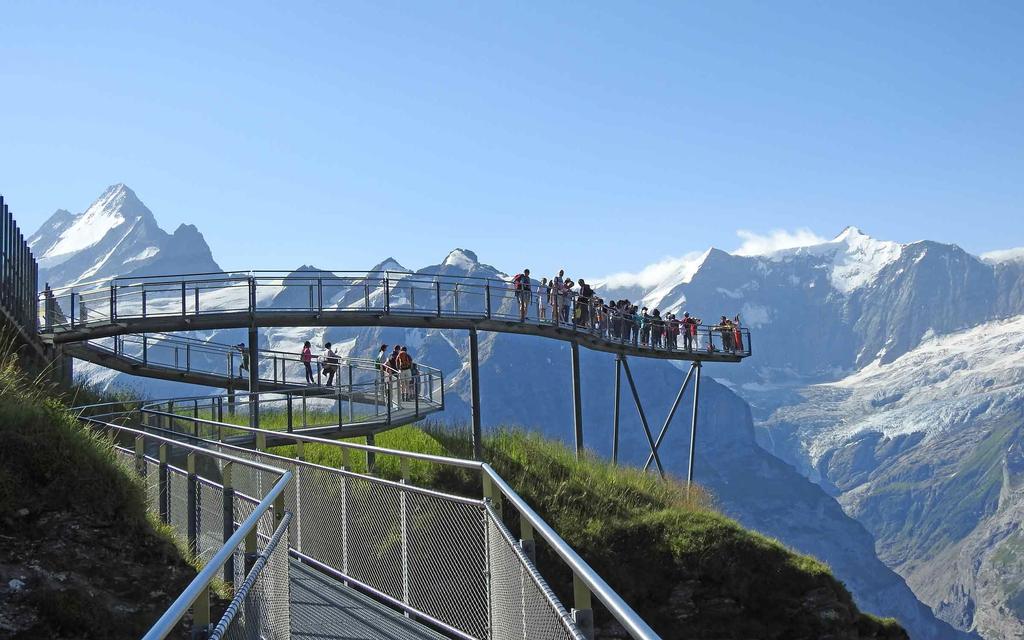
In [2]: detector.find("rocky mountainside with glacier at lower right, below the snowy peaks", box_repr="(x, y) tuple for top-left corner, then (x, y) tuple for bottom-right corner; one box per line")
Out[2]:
(759, 315), (1024, 638)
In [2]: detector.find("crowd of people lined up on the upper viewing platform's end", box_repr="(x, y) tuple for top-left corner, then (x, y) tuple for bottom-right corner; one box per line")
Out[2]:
(512, 269), (743, 353)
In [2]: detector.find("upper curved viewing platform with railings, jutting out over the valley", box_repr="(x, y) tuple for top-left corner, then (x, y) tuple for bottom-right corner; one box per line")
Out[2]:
(39, 271), (752, 362)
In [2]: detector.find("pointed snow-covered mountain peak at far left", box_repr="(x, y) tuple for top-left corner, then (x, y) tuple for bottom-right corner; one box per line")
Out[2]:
(29, 184), (220, 288)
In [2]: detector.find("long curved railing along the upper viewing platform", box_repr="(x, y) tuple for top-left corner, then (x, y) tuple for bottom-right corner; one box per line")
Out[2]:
(39, 271), (752, 357)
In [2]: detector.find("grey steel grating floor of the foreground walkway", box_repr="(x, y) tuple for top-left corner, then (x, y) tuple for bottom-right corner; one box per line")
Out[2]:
(289, 560), (444, 640)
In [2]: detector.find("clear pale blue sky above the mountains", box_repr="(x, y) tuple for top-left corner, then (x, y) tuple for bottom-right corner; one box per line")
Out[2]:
(0, 1), (1024, 276)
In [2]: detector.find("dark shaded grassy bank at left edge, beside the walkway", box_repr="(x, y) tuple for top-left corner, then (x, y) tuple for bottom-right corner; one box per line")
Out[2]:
(0, 344), (195, 638)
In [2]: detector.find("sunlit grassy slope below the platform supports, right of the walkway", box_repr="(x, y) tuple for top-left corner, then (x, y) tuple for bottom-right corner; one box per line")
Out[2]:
(281, 427), (906, 639)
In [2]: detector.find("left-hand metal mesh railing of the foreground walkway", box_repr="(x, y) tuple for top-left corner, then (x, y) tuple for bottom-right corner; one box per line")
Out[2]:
(81, 403), (294, 640)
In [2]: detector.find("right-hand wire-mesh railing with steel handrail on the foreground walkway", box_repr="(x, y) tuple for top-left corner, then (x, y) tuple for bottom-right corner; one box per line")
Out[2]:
(81, 396), (657, 640)
